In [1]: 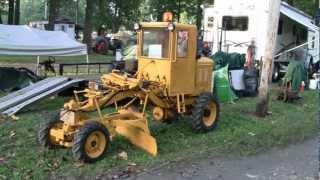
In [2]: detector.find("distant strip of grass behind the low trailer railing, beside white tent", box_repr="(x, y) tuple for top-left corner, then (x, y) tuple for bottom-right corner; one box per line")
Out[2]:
(0, 54), (114, 64)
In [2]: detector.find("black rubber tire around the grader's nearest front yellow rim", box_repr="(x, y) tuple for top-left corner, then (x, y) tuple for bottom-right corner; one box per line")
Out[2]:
(72, 122), (110, 163)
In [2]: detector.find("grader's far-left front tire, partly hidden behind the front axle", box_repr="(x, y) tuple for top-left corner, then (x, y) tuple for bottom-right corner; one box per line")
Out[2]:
(37, 114), (60, 148)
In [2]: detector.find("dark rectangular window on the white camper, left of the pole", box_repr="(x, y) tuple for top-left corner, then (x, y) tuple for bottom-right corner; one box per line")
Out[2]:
(222, 16), (249, 31)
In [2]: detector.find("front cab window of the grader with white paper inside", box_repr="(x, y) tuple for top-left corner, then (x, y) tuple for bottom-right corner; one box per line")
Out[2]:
(142, 28), (169, 59)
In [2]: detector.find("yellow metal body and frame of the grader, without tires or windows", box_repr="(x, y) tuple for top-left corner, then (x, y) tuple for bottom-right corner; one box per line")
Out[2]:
(49, 22), (213, 159)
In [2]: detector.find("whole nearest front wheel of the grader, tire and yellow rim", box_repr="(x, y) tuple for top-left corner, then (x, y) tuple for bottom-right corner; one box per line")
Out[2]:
(72, 122), (110, 162)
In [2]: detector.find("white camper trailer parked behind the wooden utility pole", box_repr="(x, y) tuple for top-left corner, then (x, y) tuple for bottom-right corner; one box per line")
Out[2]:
(203, 0), (319, 79)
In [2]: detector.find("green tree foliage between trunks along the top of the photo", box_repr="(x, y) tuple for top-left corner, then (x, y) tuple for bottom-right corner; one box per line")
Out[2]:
(0, 0), (319, 32)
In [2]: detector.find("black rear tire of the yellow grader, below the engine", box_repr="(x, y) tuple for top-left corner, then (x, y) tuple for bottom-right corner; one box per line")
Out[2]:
(191, 93), (220, 133)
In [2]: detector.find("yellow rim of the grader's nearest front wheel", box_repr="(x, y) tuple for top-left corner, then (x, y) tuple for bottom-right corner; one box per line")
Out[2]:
(85, 131), (107, 158)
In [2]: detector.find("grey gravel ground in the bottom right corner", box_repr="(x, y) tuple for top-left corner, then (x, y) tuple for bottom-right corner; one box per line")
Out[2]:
(131, 139), (319, 180)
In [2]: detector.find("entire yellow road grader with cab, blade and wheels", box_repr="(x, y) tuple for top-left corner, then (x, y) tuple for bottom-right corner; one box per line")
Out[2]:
(38, 17), (219, 162)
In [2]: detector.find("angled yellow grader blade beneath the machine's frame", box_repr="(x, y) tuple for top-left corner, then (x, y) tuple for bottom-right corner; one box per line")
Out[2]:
(116, 120), (158, 156)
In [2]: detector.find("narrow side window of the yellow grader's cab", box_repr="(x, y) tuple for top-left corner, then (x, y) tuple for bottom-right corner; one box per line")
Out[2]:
(177, 31), (189, 58)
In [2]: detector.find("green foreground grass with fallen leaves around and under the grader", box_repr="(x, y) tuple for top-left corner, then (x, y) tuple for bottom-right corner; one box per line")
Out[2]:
(0, 91), (318, 179)
